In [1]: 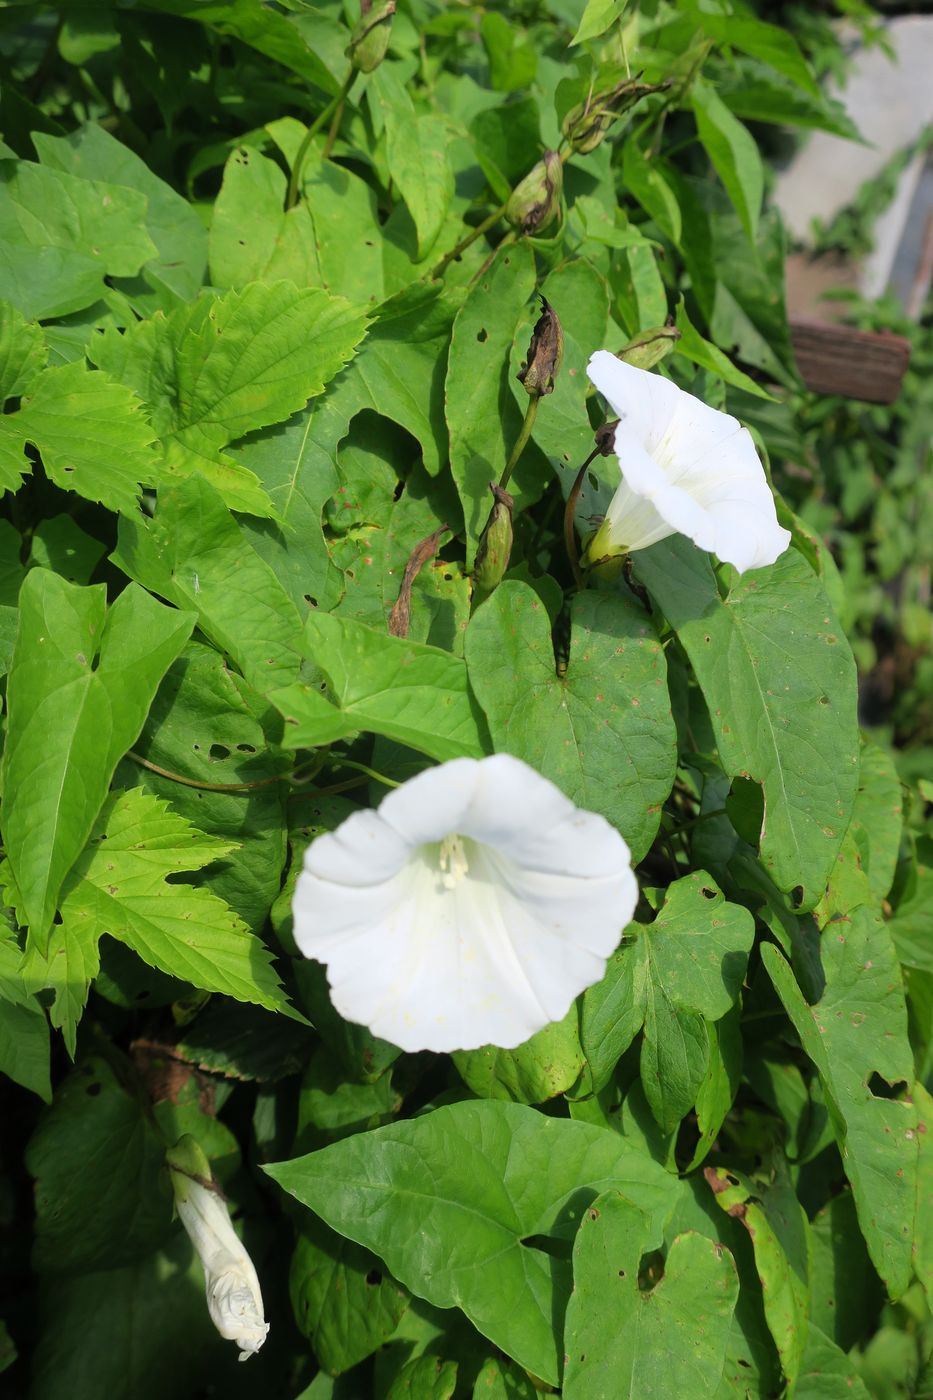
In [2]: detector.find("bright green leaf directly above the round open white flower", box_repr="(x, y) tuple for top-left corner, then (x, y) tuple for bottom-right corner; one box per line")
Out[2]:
(269, 612), (486, 762)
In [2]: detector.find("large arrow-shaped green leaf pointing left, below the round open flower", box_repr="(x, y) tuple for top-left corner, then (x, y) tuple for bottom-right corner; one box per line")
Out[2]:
(266, 1102), (677, 1385)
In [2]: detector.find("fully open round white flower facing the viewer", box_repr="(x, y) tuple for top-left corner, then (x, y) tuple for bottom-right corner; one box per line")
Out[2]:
(293, 753), (637, 1050)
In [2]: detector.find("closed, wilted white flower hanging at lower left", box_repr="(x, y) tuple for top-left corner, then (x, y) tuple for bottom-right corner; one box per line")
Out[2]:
(165, 1135), (269, 1361)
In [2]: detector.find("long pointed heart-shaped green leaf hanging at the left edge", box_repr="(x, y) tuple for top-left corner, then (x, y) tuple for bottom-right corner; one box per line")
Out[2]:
(1, 568), (195, 949)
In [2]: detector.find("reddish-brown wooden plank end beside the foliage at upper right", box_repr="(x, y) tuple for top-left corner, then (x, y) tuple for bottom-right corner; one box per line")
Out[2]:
(790, 316), (911, 403)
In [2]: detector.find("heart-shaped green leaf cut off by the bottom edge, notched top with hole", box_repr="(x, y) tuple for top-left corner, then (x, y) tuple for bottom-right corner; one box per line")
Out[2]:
(563, 1190), (738, 1400)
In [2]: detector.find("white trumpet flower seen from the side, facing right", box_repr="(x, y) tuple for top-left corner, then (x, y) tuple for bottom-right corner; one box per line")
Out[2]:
(587, 350), (790, 573)
